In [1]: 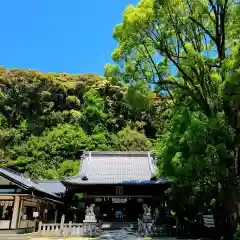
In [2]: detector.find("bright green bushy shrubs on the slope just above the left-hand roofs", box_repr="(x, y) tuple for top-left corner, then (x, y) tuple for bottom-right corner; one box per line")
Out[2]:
(9, 124), (90, 178)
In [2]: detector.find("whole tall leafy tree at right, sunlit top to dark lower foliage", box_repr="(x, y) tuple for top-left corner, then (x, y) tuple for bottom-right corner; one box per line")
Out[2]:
(109, 0), (240, 236)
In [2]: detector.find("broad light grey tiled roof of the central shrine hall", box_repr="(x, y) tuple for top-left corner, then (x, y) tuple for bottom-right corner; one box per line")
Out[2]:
(63, 152), (166, 185)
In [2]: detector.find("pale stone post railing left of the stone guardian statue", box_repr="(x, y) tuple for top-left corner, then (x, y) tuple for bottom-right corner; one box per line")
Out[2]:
(38, 219), (98, 237)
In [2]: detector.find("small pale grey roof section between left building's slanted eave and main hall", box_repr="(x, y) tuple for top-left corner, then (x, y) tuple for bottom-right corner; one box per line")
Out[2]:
(33, 180), (66, 194)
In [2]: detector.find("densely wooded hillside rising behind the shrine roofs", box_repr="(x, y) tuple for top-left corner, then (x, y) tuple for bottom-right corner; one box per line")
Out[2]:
(0, 68), (160, 179)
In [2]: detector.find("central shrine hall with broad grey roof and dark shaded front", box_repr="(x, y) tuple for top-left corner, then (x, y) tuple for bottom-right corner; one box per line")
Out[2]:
(62, 151), (169, 221)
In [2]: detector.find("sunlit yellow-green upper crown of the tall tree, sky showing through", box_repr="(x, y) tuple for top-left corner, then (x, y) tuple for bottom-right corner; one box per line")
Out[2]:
(108, 0), (238, 116)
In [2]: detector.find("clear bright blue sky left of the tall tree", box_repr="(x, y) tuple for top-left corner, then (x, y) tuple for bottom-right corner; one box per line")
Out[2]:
(0, 0), (138, 75)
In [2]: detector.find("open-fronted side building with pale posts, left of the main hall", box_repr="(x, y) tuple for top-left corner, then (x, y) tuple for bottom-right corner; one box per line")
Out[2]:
(0, 167), (65, 231)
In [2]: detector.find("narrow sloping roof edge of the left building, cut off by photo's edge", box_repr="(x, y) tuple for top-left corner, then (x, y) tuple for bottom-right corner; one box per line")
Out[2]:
(0, 167), (62, 198)
